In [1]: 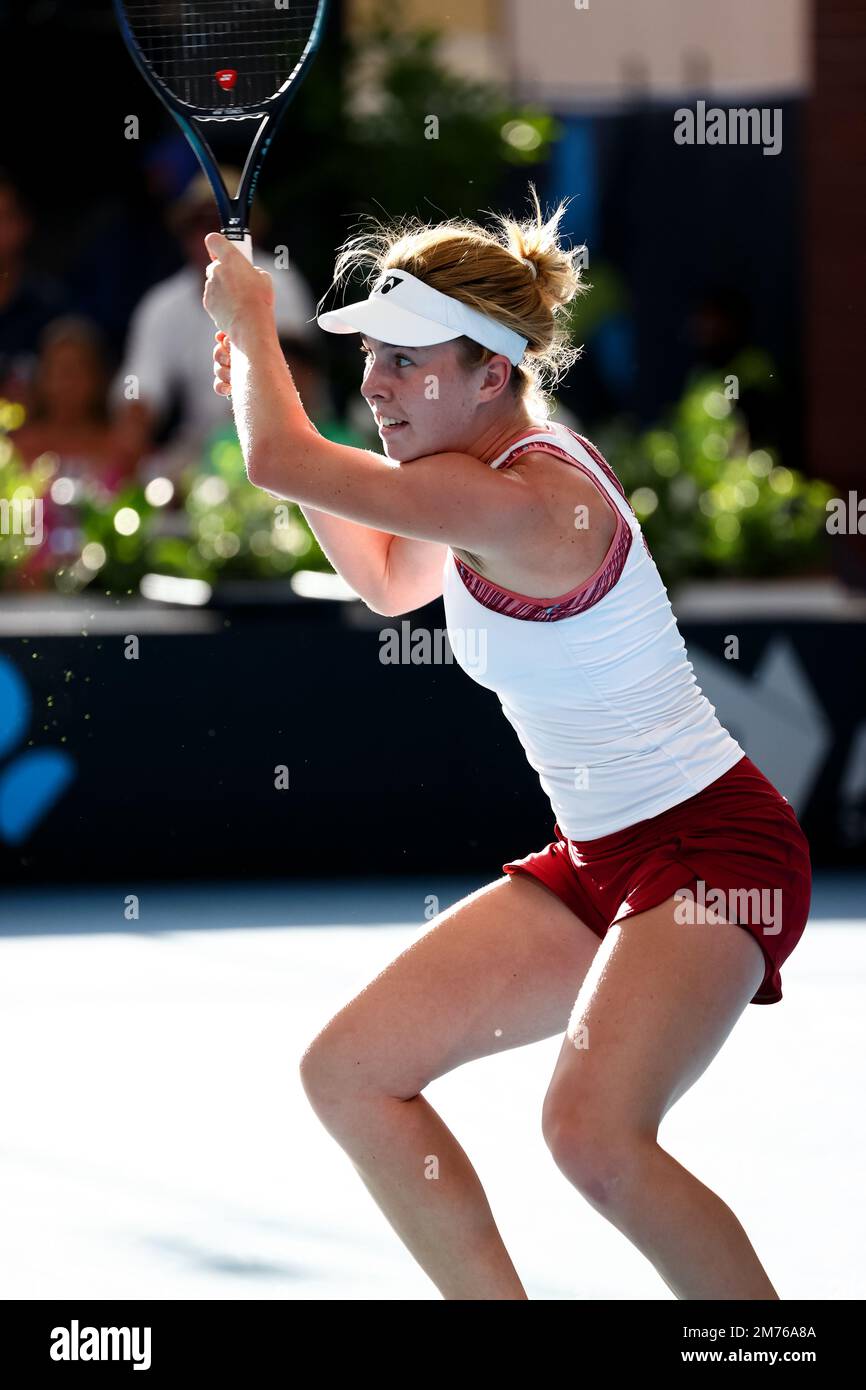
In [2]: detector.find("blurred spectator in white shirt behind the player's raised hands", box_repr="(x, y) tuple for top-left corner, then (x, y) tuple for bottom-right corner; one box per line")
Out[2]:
(111, 168), (316, 477)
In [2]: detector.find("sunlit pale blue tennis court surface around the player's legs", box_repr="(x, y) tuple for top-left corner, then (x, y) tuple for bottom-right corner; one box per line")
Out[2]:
(0, 874), (866, 1301)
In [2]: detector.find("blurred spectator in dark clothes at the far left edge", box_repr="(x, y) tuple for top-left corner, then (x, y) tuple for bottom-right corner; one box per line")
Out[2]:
(0, 170), (70, 406)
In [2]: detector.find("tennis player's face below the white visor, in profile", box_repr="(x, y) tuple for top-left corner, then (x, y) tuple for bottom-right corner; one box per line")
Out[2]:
(361, 336), (494, 461)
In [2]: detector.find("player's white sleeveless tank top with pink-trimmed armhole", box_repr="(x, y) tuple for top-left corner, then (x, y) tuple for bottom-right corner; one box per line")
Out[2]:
(442, 421), (744, 840)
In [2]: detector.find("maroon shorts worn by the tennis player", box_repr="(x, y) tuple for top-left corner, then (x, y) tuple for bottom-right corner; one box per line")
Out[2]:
(502, 756), (812, 1004)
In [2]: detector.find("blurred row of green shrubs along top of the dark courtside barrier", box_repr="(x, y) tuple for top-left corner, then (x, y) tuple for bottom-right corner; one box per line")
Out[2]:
(0, 372), (834, 594)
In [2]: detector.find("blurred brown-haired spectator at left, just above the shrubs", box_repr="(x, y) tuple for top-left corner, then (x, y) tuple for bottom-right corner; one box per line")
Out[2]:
(11, 317), (138, 492)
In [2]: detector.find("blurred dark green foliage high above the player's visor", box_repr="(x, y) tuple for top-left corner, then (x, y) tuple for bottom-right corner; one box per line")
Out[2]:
(268, 3), (562, 261)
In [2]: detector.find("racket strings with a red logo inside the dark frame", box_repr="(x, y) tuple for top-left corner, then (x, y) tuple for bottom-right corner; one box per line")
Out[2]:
(124, 0), (321, 115)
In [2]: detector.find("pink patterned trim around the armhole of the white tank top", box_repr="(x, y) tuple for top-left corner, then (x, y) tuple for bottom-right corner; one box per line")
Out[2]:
(455, 430), (631, 623)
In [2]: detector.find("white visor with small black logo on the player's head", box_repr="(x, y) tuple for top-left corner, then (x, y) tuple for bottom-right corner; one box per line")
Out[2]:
(317, 270), (528, 367)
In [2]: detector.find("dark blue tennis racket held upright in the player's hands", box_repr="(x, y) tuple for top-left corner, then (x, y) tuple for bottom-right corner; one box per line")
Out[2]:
(114, 0), (327, 261)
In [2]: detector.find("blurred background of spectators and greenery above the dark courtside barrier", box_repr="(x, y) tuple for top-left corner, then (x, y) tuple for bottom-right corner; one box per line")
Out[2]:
(0, 0), (866, 595)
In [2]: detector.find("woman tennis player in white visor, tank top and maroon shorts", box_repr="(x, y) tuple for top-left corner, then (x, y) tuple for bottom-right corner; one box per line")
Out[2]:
(204, 189), (810, 1300)
